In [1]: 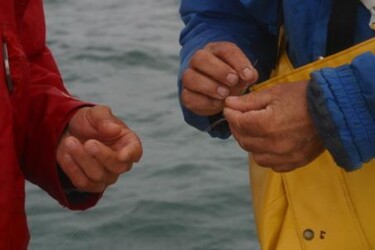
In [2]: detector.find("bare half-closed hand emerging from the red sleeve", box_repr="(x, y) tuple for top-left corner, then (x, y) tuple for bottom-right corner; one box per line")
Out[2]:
(57, 106), (142, 193)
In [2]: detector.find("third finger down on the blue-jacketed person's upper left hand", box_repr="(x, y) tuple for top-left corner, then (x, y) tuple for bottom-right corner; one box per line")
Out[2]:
(182, 69), (229, 100)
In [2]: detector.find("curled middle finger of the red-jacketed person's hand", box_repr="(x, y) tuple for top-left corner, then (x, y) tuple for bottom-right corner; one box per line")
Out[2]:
(84, 140), (133, 175)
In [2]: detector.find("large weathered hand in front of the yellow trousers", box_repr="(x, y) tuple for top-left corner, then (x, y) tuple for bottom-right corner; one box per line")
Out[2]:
(224, 81), (324, 172)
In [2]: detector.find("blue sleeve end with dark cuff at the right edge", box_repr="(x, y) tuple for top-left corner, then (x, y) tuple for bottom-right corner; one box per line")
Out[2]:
(307, 52), (375, 171)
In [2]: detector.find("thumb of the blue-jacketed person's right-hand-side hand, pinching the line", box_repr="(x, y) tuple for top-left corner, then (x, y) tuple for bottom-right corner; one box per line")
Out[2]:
(225, 90), (273, 112)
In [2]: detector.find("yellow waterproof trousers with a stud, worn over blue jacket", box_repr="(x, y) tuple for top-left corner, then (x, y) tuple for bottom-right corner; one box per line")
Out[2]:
(249, 39), (375, 250)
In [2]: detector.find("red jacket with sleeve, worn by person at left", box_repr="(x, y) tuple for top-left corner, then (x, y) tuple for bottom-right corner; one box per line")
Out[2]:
(0, 0), (99, 250)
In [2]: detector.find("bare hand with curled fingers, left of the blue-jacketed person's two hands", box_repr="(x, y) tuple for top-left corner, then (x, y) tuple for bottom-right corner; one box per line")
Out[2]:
(181, 42), (258, 116)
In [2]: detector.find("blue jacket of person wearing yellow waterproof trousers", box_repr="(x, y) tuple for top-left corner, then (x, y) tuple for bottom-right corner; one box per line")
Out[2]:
(178, 0), (375, 170)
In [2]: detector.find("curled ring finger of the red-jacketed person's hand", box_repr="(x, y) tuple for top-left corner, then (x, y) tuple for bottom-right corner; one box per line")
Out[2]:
(64, 137), (105, 182)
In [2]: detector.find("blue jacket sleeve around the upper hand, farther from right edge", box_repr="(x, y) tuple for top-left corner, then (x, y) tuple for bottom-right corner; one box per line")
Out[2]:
(178, 0), (277, 138)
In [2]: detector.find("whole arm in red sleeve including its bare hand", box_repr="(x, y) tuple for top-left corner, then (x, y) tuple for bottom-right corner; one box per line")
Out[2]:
(11, 1), (142, 209)
